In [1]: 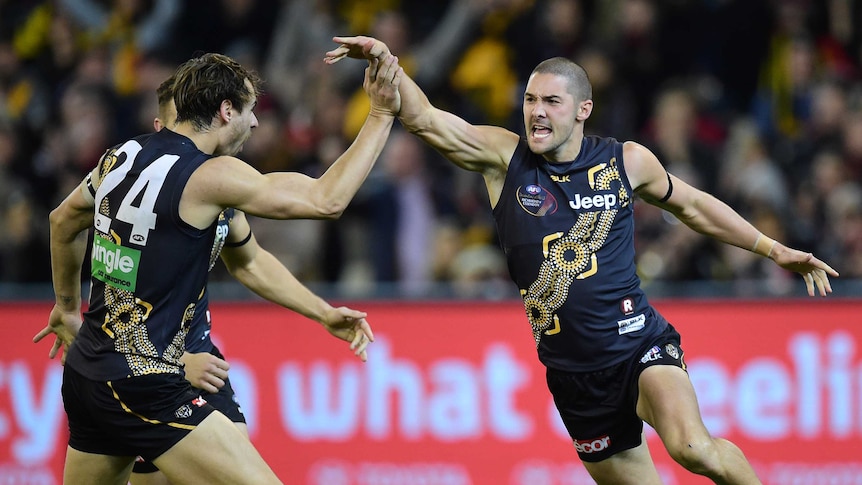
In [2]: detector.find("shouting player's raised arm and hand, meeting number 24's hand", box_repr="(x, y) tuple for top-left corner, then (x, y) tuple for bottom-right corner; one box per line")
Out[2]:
(326, 36), (518, 205)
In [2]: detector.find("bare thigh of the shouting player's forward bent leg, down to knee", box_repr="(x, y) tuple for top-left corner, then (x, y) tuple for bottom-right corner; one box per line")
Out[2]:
(637, 365), (709, 449)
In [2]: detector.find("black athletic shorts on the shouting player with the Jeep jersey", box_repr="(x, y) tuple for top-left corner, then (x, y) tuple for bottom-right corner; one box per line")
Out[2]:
(546, 324), (685, 462)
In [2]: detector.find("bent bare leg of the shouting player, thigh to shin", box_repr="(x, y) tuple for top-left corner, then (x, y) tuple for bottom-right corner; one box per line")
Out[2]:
(637, 365), (761, 485)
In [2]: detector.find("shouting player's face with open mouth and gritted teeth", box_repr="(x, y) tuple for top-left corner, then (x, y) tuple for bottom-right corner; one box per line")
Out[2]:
(524, 73), (581, 161)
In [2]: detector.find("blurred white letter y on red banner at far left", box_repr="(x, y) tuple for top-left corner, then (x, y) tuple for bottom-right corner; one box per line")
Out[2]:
(0, 361), (63, 466)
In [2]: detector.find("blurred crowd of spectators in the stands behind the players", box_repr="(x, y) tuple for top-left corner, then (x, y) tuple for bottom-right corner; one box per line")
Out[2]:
(0, 0), (862, 297)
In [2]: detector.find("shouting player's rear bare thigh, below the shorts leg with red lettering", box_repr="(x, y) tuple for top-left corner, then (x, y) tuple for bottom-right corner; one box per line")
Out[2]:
(583, 438), (661, 485)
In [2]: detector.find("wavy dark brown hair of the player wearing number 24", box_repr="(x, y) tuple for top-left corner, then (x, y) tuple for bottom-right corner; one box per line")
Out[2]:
(173, 53), (261, 130)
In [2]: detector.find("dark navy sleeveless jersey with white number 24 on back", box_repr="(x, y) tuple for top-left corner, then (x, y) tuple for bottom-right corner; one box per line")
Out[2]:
(66, 130), (217, 380)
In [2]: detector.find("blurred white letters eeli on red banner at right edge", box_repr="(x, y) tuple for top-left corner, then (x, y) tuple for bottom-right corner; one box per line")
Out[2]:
(688, 331), (862, 441)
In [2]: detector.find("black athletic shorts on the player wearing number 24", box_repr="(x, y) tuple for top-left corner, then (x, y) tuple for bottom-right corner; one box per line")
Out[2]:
(62, 365), (215, 461)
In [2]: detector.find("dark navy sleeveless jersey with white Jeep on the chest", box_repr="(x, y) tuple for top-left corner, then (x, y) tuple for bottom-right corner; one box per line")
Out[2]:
(494, 136), (667, 372)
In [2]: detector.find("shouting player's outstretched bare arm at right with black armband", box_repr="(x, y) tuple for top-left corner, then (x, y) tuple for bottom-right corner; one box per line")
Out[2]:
(623, 142), (838, 296)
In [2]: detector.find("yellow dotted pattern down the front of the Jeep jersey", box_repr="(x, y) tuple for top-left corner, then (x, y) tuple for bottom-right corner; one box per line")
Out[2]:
(523, 158), (630, 347)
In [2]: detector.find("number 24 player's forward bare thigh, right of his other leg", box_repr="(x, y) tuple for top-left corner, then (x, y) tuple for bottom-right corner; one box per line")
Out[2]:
(153, 413), (281, 485)
